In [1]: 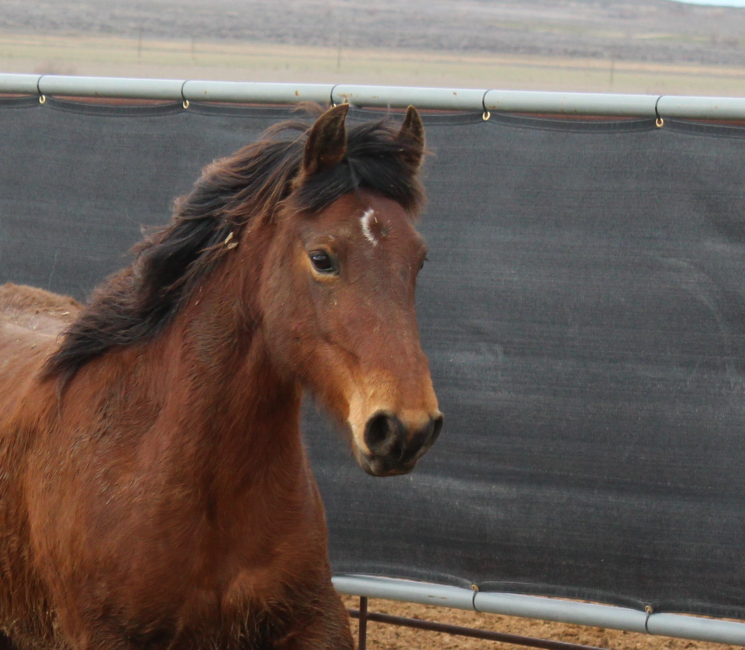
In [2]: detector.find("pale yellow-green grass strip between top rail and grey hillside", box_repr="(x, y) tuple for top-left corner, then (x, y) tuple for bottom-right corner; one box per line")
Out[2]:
(0, 34), (745, 96)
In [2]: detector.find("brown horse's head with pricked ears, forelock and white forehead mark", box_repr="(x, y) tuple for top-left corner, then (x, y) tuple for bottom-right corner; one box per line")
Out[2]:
(259, 105), (443, 476)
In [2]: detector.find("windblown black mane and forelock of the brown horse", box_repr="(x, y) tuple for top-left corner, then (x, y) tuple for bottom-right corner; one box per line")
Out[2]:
(42, 105), (424, 385)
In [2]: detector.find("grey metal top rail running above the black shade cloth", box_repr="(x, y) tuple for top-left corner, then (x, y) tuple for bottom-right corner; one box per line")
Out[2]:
(0, 74), (745, 120)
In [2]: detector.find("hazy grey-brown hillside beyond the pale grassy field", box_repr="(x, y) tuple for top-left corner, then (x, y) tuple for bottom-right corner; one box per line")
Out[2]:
(0, 0), (745, 66)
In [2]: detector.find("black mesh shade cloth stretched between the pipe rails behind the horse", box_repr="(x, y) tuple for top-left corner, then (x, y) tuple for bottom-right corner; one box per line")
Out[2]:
(0, 99), (745, 618)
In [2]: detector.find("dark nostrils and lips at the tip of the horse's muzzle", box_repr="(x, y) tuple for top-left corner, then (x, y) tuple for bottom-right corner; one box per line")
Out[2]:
(358, 411), (443, 476)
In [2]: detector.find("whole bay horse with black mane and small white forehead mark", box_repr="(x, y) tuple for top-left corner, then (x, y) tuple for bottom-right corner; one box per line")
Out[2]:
(0, 105), (442, 650)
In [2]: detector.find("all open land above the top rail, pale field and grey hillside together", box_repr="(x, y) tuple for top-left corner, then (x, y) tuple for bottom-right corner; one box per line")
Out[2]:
(0, 0), (745, 96)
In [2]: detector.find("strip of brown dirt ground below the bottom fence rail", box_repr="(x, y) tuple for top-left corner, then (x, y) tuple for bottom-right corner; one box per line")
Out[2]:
(344, 596), (736, 650)
